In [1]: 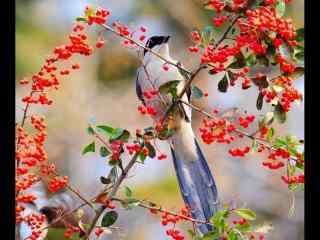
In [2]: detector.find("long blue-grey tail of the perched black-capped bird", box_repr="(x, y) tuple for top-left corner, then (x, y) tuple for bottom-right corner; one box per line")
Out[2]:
(171, 138), (219, 234)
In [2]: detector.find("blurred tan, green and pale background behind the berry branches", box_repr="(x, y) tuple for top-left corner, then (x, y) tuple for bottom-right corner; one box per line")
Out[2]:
(16, 0), (304, 240)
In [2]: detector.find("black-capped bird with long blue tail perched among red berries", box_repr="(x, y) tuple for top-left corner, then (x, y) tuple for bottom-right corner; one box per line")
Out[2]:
(136, 36), (220, 235)
